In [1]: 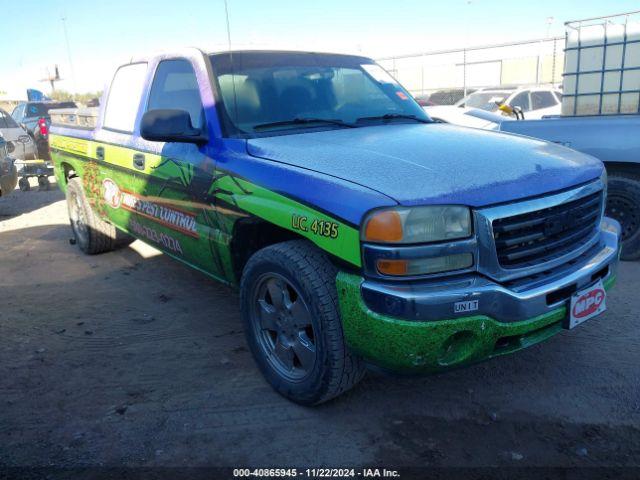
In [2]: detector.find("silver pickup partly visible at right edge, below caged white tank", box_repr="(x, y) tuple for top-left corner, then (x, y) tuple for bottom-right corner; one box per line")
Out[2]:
(498, 115), (640, 260)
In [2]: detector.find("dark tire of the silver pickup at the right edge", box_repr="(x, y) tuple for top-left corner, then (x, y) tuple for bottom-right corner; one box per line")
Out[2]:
(606, 170), (640, 260)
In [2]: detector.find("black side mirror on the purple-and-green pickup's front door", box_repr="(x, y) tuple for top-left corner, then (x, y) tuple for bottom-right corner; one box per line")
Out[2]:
(140, 109), (209, 145)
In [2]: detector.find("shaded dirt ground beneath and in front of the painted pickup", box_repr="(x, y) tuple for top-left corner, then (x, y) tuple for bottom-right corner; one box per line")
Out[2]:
(0, 179), (640, 467)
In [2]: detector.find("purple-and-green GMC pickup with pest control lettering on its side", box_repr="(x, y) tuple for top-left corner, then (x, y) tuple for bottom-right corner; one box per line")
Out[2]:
(50, 49), (620, 405)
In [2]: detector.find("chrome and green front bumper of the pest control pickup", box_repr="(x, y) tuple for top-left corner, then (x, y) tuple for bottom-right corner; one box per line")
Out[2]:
(337, 218), (620, 372)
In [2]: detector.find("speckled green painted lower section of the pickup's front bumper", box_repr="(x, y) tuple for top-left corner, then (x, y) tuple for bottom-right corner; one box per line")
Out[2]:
(336, 272), (615, 373)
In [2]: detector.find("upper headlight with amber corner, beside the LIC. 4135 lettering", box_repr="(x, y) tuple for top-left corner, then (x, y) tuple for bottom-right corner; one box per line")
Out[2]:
(362, 205), (471, 244)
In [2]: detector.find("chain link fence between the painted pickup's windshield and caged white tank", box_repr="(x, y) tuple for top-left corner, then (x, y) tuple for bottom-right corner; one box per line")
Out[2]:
(378, 37), (565, 96)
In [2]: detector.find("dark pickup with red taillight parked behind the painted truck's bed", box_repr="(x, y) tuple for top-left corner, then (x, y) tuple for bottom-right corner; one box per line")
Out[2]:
(11, 102), (77, 161)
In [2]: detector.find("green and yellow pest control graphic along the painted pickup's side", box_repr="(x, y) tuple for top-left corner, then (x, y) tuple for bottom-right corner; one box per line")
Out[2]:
(50, 135), (361, 283)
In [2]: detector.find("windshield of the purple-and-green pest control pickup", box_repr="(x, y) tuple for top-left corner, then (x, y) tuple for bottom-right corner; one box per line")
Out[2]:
(211, 52), (429, 137)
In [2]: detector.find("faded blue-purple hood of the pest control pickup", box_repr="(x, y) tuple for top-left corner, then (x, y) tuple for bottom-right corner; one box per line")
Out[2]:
(247, 123), (603, 207)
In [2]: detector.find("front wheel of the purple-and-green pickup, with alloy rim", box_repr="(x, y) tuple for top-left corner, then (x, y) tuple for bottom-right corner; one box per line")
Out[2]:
(240, 240), (365, 405)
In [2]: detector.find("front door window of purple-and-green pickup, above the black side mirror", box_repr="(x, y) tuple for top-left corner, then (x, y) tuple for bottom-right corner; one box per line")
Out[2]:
(147, 59), (204, 128)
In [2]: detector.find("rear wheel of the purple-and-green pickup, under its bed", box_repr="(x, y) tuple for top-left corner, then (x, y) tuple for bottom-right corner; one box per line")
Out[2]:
(66, 177), (135, 255)
